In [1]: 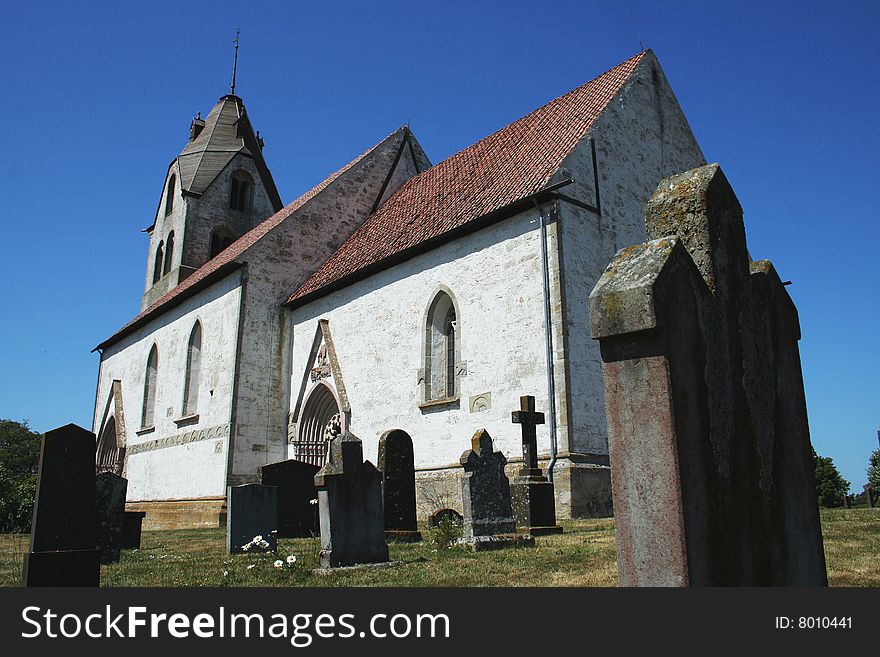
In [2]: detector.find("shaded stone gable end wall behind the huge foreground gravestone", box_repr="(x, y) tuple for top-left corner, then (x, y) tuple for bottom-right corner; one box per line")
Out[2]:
(557, 55), (705, 457)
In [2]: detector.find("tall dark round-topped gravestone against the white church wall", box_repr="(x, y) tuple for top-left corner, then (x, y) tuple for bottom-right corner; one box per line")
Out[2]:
(379, 429), (422, 543)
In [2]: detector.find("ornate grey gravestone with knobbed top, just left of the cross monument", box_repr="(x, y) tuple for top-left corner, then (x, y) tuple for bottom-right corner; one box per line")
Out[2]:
(459, 429), (516, 541)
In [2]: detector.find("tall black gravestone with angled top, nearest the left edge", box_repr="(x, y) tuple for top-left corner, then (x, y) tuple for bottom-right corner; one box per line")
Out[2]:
(22, 424), (101, 586)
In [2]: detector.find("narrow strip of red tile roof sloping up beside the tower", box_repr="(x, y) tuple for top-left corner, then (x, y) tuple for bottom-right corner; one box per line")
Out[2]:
(95, 127), (408, 349)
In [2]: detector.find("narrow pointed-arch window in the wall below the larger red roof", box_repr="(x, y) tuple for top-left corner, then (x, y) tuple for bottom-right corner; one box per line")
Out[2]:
(425, 291), (459, 401)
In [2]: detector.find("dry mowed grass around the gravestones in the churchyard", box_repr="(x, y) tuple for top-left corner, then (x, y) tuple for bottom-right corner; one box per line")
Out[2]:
(0, 509), (880, 587)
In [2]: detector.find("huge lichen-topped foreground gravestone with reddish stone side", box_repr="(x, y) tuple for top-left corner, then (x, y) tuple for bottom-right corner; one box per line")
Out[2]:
(590, 164), (827, 586)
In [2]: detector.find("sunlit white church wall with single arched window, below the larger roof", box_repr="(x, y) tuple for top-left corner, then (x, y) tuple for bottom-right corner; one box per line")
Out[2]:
(290, 211), (549, 480)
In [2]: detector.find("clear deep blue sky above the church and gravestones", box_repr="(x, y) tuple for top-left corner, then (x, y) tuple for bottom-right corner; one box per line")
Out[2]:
(0, 0), (880, 490)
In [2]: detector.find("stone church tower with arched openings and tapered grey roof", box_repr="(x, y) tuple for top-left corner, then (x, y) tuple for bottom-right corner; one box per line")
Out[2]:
(141, 86), (281, 310)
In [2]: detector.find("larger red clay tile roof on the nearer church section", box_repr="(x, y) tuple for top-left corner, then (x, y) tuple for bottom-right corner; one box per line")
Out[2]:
(288, 51), (647, 302)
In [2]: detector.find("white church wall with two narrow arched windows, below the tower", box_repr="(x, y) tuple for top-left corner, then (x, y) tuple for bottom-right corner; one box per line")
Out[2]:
(93, 272), (241, 501)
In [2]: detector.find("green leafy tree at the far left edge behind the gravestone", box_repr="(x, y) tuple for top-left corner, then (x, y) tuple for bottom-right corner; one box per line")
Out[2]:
(0, 420), (40, 533)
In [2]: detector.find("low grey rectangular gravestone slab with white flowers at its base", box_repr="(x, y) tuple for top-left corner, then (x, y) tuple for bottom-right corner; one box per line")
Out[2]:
(226, 484), (278, 554)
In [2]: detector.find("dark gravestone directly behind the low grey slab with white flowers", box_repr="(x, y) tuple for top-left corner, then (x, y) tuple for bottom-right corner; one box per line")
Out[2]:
(260, 459), (321, 538)
